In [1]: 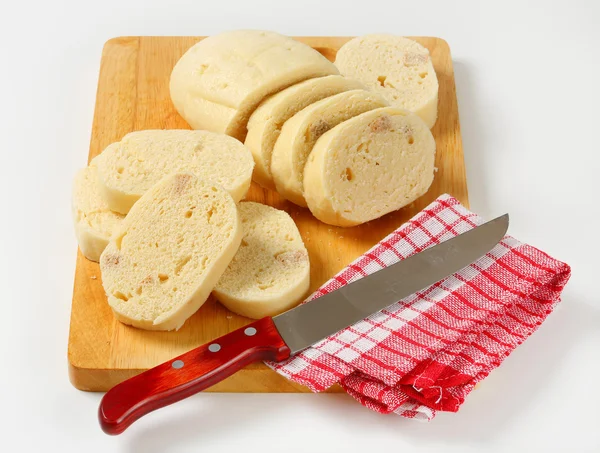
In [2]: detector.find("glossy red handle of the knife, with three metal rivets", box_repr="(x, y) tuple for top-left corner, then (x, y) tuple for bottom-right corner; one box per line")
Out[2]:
(98, 317), (290, 434)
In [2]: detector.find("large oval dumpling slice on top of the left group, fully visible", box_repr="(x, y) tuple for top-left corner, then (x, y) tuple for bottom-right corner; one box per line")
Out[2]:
(100, 173), (242, 330)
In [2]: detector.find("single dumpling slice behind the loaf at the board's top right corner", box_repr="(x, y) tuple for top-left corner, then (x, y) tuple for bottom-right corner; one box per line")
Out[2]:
(335, 34), (438, 129)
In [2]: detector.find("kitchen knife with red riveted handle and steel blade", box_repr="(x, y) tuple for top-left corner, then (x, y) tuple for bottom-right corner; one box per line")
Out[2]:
(98, 214), (508, 434)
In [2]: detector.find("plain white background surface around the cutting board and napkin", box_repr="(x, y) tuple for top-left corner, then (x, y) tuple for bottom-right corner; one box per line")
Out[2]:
(0, 0), (600, 453)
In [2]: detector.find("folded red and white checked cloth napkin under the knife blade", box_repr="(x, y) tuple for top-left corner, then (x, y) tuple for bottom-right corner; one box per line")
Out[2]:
(267, 195), (571, 420)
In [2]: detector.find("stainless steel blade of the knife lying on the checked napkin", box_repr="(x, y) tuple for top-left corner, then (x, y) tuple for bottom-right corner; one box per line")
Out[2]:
(273, 214), (508, 354)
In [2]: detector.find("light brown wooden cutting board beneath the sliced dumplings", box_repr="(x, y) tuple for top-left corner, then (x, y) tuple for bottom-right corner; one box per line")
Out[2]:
(68, 37), (468, 392)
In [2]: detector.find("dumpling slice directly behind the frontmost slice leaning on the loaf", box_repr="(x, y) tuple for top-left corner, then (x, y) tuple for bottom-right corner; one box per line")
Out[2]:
(271, 89), (388, 207)
